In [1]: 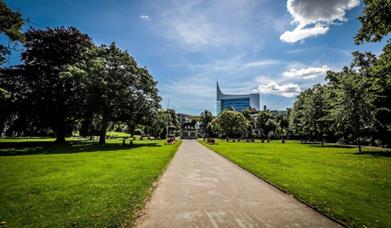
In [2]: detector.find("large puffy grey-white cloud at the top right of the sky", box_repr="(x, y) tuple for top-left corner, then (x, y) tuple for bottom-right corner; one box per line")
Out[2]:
(280, 0), (360, 43)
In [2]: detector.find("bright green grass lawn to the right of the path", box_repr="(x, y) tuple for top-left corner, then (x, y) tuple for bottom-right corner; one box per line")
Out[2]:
(201, 140), (391, 227)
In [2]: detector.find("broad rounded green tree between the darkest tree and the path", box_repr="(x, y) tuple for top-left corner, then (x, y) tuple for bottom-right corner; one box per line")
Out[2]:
(66, 43), (161, 144)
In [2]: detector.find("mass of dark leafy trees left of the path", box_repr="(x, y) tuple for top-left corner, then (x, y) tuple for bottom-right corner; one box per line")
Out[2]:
(0, 1), (161, 143)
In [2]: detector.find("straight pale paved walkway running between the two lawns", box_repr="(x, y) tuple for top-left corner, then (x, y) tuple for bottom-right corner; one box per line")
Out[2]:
(136, 140), (338, 228)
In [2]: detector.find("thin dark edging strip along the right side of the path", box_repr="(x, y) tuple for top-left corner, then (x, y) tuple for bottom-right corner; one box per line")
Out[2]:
(201, 139), (349, 227)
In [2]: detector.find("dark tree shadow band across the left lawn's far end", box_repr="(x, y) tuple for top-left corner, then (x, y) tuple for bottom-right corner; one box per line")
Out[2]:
(0, 141), (161, 156)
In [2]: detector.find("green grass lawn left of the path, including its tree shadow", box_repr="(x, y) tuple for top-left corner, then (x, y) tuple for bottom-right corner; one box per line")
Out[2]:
(0, 136), (180, 227)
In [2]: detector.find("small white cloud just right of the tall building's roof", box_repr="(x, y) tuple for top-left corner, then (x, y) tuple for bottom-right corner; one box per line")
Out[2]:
(258, 81), (301, 97)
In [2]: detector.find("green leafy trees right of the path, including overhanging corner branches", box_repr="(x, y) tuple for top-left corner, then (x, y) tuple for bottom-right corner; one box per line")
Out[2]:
(290, 0), (391, 151)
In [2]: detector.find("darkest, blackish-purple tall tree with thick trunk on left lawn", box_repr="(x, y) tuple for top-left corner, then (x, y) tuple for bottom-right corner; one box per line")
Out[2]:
(22, 27), (92, 143)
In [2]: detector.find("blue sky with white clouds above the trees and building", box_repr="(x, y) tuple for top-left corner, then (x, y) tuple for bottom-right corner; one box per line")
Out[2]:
(5, 0), (386, 114)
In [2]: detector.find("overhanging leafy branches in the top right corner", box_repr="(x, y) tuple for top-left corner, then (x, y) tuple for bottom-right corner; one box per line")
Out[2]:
(354, 0), (391, 44)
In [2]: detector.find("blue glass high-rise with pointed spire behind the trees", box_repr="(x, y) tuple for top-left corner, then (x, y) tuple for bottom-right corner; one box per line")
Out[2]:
(216, 83), (260, 114)
